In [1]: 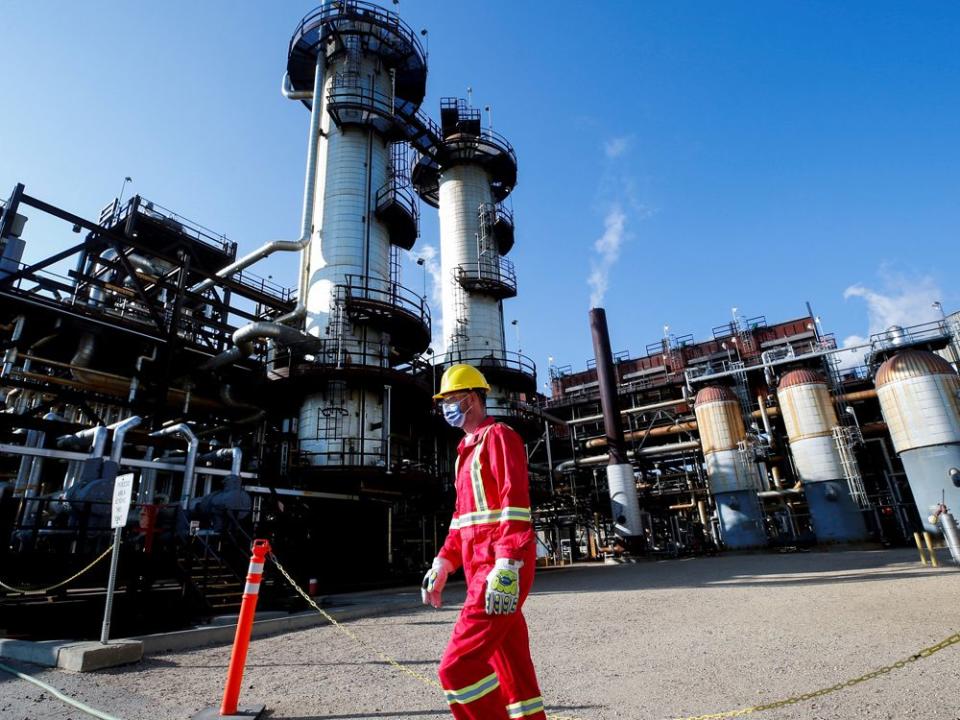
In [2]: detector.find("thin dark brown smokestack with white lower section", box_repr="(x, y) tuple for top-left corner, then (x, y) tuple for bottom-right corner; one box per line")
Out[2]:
(590, 308), (643, 539)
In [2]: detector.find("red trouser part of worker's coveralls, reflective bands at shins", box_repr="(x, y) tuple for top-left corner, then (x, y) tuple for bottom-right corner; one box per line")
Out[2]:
(439, 562), (546, 720)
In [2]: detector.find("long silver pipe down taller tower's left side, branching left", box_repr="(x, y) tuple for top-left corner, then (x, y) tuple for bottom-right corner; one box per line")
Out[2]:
(191, 48), (326, 324)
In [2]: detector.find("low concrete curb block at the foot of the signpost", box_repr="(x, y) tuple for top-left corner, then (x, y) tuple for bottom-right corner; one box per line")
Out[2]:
(0, 640), (143, 672)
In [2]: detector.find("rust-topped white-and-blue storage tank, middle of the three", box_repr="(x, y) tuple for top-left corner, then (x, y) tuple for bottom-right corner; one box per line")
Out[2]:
(777, 368), (867, 543)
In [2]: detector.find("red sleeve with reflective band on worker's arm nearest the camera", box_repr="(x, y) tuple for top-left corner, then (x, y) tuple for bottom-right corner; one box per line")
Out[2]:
(486, 425), (536, 560)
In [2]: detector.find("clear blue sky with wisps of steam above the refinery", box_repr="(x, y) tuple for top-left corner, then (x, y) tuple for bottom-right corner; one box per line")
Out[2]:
(0, 0), (960, 390)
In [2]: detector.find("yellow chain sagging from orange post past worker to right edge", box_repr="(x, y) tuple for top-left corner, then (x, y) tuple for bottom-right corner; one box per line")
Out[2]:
(269, 553), (960, 720)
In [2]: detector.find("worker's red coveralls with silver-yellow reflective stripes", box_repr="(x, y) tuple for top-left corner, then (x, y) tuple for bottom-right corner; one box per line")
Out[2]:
(439, 418), (546, 720)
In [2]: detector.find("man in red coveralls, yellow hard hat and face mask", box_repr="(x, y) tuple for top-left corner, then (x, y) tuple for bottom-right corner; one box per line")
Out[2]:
(422, 365), (546, 720)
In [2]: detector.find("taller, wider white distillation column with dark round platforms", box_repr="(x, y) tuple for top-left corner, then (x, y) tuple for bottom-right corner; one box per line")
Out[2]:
(287, 0), (429, 466)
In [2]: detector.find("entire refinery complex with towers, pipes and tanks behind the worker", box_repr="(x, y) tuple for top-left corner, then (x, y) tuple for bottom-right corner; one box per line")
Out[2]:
(0, 0), (960, 639)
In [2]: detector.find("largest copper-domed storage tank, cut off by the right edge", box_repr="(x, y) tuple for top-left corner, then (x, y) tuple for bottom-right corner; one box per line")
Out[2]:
(874, 350), (960, 532)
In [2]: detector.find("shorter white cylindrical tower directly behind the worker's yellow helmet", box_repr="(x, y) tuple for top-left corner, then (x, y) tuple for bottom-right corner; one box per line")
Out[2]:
(413, 98), (536, 419)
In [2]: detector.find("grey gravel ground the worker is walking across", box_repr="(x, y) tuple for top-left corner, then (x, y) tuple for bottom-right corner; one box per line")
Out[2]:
(0, 550), (960, 720)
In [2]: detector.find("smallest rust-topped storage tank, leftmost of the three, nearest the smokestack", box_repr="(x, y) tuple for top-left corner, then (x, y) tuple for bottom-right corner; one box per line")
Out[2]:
(694, 386), (767, 549)
